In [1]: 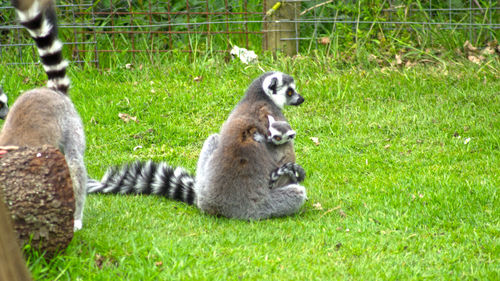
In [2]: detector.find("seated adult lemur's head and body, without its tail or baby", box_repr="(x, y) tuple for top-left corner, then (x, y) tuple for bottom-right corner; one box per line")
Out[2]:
(195, 72), (307, 219)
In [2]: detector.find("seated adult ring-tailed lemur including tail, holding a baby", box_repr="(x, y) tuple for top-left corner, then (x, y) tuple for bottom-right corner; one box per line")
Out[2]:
(88, 72), (307, 219)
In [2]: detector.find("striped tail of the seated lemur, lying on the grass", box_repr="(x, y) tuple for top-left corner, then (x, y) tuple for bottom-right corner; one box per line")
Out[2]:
(87, 161), (196, 205)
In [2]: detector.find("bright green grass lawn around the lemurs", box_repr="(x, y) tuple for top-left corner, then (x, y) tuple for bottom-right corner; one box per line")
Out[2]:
(0, 54), (500, 280)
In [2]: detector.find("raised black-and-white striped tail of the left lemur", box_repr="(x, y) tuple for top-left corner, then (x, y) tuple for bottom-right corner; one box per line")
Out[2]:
(12, 0), (69, 94)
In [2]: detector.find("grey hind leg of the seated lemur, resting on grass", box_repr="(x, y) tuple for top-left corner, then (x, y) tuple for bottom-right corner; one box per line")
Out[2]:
(255, 184), (307, 219)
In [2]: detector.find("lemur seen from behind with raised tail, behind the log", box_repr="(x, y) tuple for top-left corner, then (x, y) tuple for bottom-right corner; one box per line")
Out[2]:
(0, 0), (87, 230)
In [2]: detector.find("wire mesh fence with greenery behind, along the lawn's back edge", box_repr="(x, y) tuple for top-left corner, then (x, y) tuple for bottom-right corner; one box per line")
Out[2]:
(0, 0), (500, 65)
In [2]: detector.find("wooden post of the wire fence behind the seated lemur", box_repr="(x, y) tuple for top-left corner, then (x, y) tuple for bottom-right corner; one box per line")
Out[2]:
(262, 0), (300, 56)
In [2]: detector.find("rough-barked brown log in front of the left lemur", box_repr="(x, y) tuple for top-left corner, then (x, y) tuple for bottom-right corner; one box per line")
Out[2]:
(0, 145), (75, 257)
